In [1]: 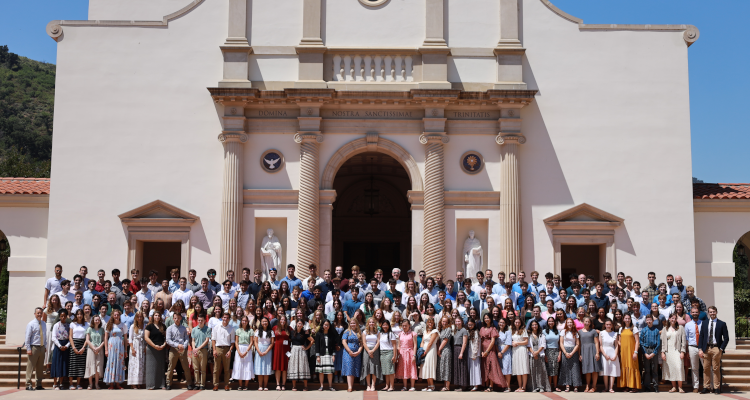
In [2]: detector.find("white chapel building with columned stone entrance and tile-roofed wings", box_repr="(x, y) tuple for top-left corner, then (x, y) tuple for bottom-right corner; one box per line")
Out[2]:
(0, 0), (750, 346)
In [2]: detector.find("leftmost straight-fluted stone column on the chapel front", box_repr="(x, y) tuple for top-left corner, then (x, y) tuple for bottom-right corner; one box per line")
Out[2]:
(219, 132), (247, 279)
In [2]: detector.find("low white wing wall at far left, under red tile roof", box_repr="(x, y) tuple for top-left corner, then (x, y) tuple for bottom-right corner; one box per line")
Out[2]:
(0, 205), (48, 345)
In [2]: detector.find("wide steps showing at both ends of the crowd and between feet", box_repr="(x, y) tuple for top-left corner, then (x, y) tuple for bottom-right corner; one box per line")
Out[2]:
(0, 335), (750, 392)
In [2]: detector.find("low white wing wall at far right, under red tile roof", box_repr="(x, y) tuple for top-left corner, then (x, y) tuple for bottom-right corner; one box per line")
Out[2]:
(695, 210), (750, 349)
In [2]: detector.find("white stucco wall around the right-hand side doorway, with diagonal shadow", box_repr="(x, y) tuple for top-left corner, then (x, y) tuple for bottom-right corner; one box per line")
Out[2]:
(520, 0), (696, 284)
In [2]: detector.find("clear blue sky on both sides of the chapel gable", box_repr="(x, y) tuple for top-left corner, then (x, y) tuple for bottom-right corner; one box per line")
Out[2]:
(0, 0), (750, 183)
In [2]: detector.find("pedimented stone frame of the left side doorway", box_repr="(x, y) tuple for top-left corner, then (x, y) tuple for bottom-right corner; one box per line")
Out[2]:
(118, 200), (200, 276)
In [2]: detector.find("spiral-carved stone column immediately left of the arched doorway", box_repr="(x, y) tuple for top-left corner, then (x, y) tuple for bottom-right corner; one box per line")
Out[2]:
(294, 132), (323, 278)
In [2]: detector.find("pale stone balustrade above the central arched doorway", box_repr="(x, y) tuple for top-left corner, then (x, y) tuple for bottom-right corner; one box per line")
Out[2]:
(333, 54), (414, 83)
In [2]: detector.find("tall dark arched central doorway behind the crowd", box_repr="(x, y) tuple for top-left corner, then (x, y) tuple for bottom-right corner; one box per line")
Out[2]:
(332, 152), (412, 278)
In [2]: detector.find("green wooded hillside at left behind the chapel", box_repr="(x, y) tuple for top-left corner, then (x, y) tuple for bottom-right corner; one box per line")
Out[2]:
(0, 46), (55, 178)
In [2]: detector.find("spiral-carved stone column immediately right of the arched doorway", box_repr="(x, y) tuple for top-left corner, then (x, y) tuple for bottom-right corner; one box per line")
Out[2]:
(419, 133), (448, 277)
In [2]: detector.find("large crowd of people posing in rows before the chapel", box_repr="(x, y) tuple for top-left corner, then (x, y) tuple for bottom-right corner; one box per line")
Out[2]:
(25, 264), (729, 393)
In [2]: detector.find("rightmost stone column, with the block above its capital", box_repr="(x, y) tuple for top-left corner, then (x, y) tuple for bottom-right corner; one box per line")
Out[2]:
(495, 110), (526, 274)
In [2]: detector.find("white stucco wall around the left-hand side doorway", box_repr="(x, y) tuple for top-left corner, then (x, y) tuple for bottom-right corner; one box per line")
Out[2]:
(46, 1), (228, 300)
